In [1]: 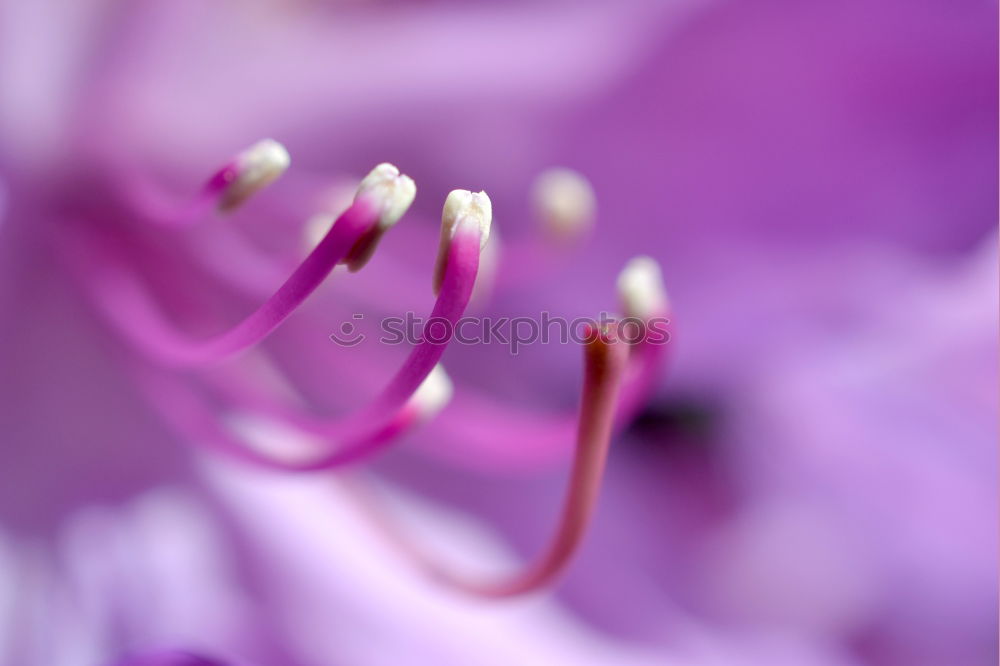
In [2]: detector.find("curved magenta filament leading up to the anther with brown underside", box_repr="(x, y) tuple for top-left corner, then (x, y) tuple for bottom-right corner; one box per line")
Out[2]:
(75, 167), (414, 366)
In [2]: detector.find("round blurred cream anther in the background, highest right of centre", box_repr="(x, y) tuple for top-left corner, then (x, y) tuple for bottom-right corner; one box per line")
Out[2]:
(532, 167), (597, 239)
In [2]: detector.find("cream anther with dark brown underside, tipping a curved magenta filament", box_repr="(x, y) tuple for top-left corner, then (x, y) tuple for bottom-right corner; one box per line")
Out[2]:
(345, 163), (417, 272)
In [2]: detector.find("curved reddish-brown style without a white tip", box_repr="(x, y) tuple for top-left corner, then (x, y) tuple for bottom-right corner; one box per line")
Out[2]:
(344, 326), (628, 598)
